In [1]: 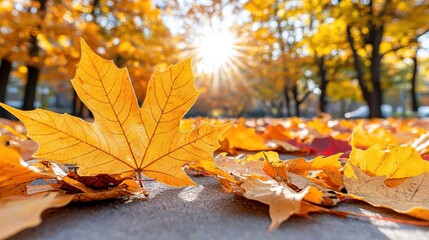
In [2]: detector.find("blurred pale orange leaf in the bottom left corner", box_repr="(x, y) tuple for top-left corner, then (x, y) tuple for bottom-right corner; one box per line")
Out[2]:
(0, 192), (73, 239)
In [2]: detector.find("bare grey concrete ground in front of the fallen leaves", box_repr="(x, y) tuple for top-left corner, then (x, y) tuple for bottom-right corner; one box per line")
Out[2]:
(10, 177), (429, 240)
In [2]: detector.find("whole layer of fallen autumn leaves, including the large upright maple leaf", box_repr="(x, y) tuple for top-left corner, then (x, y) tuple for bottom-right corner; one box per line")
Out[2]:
(0, 41), (429, 238)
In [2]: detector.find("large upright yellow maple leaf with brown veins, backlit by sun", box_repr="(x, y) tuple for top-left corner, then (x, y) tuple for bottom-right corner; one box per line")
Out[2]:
(1, 40), (229, 186)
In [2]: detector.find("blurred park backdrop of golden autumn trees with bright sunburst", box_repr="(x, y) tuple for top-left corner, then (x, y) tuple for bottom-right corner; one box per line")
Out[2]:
(0, 0), (429, 118)
